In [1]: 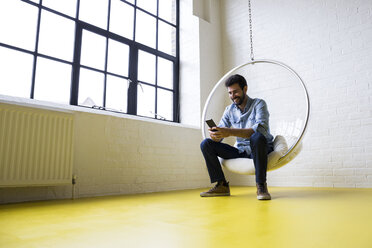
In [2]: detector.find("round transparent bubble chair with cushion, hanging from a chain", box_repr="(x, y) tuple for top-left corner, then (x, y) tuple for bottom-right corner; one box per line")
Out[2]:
(202, 59), (310, 175)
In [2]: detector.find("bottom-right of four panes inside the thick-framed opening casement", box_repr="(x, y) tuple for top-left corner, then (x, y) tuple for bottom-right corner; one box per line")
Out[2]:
(106, 76), (128, 113)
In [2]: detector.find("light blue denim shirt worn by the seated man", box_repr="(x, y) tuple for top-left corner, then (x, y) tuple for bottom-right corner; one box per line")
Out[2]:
(218, 95), (273, 155)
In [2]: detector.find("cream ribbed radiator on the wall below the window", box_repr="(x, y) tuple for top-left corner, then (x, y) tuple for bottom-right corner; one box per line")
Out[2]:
(0, 104), (73, 187)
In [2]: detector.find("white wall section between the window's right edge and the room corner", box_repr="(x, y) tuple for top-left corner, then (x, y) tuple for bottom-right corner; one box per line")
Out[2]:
(180, 0), (224, 127)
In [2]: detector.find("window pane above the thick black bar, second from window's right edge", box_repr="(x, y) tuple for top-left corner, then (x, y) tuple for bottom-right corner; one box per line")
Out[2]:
(136, 10), (156, 48)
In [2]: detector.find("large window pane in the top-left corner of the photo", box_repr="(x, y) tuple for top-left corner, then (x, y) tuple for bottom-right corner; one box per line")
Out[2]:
(0, 0), (38, 51)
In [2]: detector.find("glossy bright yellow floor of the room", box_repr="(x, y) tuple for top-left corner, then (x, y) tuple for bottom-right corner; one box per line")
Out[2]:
(0, 187), (372, 248)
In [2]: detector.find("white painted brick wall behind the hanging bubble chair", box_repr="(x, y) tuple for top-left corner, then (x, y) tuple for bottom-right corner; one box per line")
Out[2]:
(221, 0), (372, 187)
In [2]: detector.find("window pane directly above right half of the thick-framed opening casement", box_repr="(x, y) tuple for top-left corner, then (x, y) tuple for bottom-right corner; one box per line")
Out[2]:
(110, 0), (134, 40)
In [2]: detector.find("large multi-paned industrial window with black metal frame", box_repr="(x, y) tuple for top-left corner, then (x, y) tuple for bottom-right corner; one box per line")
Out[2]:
(0, 0), (179, 122)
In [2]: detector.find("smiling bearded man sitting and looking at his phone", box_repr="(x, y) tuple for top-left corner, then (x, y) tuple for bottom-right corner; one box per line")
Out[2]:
(200, 74), (273, 200)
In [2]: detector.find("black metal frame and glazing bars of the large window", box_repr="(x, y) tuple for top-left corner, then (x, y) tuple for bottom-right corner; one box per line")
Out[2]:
(0, 0), (180, 122)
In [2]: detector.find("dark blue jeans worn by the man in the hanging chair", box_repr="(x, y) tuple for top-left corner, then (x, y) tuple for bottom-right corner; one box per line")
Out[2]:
(200, 132), (273, 183)
